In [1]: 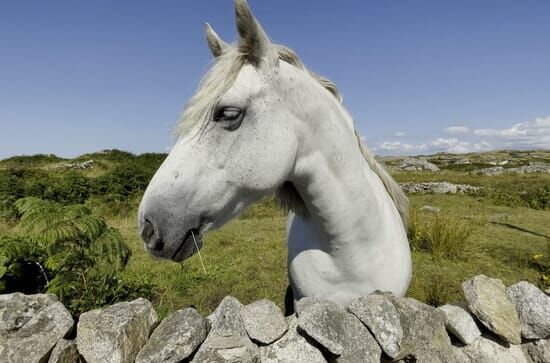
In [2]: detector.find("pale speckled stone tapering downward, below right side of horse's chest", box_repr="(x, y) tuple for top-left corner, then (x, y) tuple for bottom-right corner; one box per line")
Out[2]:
(348, 294), (403, 358)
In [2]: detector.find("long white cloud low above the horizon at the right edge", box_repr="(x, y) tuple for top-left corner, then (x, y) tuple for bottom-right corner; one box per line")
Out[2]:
(474, 116), (550, 148)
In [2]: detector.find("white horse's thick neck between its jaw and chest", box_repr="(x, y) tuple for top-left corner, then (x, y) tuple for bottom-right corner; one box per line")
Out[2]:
(293, 102), (406, 253)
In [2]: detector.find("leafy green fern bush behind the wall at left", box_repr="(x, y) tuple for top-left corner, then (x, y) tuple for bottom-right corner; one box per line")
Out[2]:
(0, 197), (152, 314)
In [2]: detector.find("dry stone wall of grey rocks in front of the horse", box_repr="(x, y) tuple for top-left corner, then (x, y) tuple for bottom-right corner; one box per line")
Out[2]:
(0, 275), (550, 363)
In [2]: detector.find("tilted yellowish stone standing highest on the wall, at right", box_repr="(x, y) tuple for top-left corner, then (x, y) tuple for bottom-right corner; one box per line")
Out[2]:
(462, 275), (521, 344)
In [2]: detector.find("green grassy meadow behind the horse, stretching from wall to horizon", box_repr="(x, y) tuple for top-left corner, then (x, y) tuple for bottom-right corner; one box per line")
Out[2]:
(0, 150), (550, 316)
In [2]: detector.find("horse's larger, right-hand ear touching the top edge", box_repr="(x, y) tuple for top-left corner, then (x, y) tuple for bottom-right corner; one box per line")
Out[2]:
(235, 0), (279, 66)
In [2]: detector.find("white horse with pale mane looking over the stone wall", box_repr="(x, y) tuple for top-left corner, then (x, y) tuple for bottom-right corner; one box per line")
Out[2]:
(138, 0), (412, 304)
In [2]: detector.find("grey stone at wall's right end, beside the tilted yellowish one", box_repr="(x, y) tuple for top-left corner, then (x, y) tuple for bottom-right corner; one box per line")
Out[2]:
(506, 281), (550, 339)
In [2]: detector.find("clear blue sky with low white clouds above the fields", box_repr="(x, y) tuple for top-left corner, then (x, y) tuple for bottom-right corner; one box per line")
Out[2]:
(0, 0), (550, 158)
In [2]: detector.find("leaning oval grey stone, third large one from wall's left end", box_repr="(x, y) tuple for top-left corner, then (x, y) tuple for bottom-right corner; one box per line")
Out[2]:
(136, 308), (210, 363)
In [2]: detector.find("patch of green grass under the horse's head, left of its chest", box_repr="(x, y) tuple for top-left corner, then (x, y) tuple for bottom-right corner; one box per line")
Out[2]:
(111, 213), (288, 315)
